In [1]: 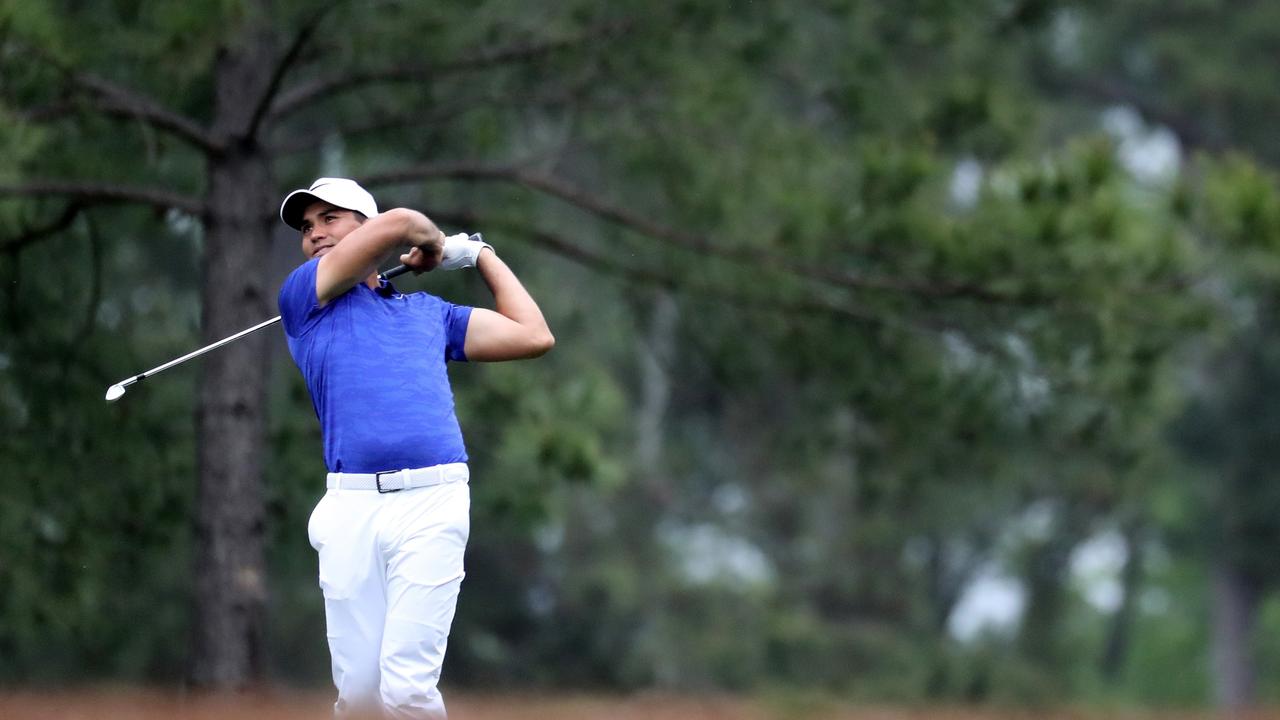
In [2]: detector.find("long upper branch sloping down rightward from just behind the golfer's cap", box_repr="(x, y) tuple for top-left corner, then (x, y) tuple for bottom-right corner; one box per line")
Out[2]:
(365, 163), (1021, 304)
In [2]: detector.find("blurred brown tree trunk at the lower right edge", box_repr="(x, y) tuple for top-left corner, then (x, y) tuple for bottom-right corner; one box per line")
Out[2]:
(1212, 557), (1258, 710)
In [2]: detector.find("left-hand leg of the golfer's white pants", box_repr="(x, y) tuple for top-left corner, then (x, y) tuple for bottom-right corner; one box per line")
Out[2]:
(307, 489), (387, 717)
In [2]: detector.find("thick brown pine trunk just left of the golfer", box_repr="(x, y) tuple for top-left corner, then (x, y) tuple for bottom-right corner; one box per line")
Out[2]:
(191, 22), (276, 689)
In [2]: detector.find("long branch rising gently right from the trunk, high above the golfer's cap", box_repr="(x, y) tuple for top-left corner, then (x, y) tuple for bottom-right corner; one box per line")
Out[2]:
(270, 23), (630, 119)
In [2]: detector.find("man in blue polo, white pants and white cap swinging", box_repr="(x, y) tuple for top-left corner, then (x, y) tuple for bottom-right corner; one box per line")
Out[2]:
(279, 178), (556, 717)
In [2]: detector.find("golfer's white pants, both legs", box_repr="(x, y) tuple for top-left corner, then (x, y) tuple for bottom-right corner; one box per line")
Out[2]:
(307, 466), (471, 719)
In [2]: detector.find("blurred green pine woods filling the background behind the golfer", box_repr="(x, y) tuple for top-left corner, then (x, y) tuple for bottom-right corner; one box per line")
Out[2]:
(0, 0), (1280, 707)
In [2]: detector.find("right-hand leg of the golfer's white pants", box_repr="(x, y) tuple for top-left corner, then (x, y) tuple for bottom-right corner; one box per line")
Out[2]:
(380, 474), (471, 720)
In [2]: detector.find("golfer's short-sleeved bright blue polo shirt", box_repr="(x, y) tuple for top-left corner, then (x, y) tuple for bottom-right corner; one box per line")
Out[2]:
(279, 259), (471, 473)
